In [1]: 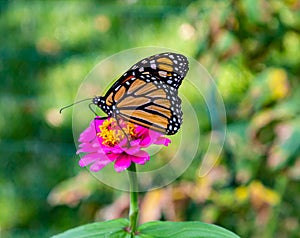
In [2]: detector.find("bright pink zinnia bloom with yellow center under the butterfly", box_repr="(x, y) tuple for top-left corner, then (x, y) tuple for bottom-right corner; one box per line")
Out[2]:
(77, 117), (171, 172)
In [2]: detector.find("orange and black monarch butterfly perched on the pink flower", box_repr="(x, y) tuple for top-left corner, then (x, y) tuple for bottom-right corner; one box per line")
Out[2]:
(93, 52), (189, 135)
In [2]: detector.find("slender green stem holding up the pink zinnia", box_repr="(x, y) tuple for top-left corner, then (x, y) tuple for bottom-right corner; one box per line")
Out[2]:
(128, 163), (139, 236)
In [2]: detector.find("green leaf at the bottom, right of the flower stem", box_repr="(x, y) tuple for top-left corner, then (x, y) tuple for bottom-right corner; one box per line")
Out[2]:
(136, 221), (239, 238)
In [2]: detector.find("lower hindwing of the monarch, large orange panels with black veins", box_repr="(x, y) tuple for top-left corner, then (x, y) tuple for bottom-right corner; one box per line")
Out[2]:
(115, 70), (182, 135)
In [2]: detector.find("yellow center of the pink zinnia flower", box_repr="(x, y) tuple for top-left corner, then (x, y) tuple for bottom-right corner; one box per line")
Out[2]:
(97, 118), (136, 146)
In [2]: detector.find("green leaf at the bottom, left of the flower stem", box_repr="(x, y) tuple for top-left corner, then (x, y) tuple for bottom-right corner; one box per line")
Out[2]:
(52, 218), (131, 238)
